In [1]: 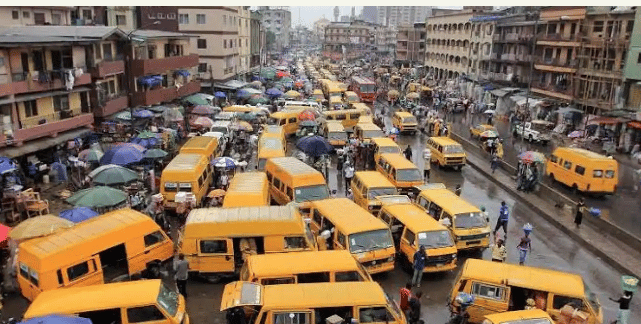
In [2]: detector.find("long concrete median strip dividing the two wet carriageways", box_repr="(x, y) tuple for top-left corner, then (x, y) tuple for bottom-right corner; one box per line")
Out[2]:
(466, 138), (641, 278)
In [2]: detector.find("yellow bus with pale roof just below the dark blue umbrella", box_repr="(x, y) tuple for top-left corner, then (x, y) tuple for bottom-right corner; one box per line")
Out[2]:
(265, 157), (329, 205)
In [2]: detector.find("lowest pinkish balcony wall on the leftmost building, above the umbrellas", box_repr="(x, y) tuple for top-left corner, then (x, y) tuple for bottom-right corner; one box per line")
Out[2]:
(0, 109), (93, 146)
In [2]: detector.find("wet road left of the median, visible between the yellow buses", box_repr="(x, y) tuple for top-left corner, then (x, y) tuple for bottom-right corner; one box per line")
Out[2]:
(3, 104), (641, 324)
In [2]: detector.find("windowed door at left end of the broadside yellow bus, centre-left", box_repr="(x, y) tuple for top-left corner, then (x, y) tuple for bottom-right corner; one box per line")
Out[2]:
(198, 238), (234, 273)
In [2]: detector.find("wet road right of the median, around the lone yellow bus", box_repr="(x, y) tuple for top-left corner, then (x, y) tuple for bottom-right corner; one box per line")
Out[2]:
(444, 114), (641, 237)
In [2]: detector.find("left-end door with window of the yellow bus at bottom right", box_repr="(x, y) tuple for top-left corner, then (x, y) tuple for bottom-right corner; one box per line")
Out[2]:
(468, 281), (510, 323)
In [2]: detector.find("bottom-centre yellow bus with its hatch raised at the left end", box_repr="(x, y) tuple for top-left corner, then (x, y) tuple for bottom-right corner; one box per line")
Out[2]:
(220, 281), (407, 324)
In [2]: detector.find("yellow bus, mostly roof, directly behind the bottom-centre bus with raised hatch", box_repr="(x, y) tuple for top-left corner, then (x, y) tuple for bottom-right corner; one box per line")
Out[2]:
(240, 250), (372, 285)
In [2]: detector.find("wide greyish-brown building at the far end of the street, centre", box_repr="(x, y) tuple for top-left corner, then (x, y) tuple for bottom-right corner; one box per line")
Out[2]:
(323, 20), (376, 60)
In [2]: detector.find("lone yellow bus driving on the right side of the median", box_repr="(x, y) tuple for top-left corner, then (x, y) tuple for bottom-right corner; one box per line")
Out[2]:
(545, 147), (619, 194)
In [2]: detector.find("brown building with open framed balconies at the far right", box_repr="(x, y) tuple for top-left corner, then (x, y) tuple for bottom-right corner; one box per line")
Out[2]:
(574, 7), (635, 114)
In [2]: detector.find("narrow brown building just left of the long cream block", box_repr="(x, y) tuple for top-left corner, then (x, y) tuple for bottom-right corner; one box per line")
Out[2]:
(396, 23), (426, 65)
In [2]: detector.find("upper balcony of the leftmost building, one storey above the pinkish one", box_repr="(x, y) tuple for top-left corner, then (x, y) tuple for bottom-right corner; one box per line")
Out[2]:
(0, 71), (91, 96)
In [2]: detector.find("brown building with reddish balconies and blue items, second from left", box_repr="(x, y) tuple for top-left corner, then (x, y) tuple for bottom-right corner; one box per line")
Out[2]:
(126, 30), (200, 107)
